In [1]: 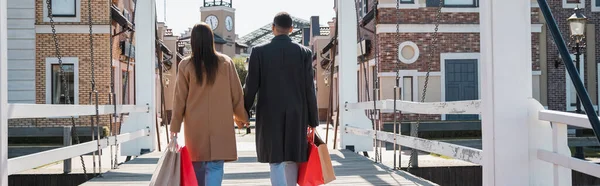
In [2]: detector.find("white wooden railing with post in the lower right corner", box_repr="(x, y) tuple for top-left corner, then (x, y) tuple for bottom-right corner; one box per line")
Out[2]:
(537, 110), (600, 179)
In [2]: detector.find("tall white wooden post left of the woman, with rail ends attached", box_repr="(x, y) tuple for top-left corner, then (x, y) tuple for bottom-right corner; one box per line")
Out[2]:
(121, 0), (157, 156)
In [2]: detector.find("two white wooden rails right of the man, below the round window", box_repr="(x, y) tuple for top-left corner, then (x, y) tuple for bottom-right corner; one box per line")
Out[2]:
(344, 100), (483, 164)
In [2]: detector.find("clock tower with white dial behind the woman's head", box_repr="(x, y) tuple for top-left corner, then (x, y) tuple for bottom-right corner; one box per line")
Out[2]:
(200, 0), (235, 58)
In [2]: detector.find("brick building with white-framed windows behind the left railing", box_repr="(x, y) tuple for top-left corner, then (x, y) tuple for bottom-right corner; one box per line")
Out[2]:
(9, 0), (141, 130)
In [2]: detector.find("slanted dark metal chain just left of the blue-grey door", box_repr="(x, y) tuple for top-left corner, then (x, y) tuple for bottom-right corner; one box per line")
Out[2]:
(408, 0), (443, 170)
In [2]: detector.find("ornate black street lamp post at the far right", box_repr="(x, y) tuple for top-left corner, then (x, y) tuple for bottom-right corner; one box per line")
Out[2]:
(567, 8), (593, 159)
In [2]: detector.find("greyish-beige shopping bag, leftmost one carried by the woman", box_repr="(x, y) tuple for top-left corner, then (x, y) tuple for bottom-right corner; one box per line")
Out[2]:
(150, 139), (181, 186)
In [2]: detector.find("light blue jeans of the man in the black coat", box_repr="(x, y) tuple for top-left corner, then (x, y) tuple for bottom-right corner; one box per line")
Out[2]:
(270, 161), (298, 186)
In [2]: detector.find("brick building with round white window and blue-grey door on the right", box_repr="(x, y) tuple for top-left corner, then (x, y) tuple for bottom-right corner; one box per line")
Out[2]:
(318, 0), (600, 134)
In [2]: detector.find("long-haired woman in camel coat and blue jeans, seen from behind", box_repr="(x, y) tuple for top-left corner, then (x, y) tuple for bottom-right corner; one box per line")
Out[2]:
(171, 23), (248, 186)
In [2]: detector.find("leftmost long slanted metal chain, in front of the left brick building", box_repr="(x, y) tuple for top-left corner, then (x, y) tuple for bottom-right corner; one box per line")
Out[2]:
(46, 0), (88, 180)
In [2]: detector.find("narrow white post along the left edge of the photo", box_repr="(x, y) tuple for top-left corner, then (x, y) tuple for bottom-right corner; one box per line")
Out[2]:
(0, 0), (8, 186)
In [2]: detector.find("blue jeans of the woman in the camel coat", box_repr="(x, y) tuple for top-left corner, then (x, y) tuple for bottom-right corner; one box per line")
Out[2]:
(192, 160), (224, 186)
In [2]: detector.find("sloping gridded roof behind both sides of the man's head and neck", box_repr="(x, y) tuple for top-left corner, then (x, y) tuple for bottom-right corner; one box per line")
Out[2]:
(237, 16), (310, 46)
